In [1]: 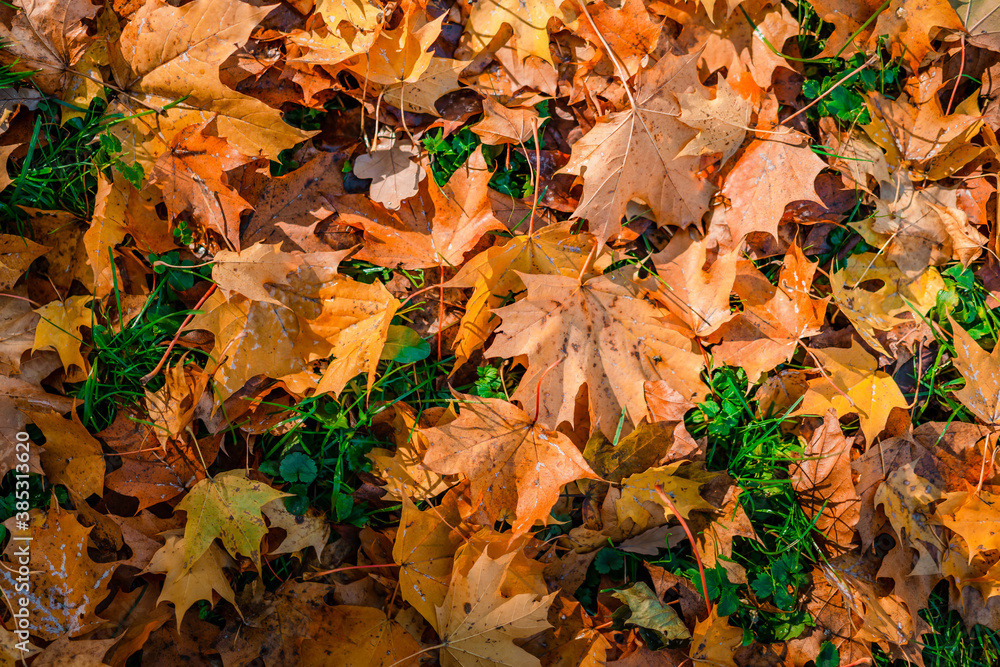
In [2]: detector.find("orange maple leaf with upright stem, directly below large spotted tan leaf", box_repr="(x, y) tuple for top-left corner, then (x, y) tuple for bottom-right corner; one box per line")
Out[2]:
(422, 394), (596, 533)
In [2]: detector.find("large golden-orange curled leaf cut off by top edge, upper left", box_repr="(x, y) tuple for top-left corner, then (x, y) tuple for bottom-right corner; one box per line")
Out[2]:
(112, 0), (315, 160)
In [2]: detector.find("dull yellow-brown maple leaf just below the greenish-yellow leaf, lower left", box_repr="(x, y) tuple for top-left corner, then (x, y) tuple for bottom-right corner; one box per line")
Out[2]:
(146, 535), (236, 630)
